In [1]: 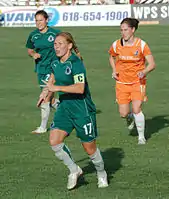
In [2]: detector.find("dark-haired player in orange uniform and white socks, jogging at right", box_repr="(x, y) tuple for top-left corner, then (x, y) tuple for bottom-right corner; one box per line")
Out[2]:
(109, 18), (155, 144)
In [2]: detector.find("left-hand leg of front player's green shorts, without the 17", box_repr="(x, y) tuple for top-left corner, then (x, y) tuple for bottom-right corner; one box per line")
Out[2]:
(50, 103), (74, 135)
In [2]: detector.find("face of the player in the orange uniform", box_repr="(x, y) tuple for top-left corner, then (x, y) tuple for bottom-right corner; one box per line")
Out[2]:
(121, 23), (135, 41)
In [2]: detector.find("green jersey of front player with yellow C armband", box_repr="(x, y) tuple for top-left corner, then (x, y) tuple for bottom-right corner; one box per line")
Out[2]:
(51, 54), (96, 118)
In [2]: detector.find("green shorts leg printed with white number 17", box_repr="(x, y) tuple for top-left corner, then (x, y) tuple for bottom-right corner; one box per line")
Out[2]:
(73, 114), (98, 142)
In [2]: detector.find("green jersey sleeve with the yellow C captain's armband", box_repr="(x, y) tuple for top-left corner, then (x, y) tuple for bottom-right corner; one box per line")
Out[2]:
(72, 60), (86, 84)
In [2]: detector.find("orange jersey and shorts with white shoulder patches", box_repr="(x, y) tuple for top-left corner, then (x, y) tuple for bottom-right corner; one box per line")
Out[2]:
(109, 38), (151, 104)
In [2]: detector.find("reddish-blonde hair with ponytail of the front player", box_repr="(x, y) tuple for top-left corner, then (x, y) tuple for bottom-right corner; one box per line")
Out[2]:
(56, 32), (83, 60)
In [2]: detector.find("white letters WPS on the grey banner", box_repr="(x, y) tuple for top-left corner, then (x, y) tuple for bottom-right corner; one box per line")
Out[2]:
(133, 6), (158, 19)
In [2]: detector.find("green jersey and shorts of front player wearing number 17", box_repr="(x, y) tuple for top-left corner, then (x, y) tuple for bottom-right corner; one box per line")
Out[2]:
(51, 53), (97, 142)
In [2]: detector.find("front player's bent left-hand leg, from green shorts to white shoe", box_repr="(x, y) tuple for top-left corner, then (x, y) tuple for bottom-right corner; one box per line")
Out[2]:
(49, 104), (83, 190)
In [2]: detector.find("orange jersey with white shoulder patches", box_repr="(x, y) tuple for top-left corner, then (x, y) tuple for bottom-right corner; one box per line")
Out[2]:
(109, 38), (151, 84)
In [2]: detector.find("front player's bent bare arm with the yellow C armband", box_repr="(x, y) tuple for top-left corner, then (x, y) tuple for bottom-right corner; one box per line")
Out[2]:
(43, 73), (85, 94)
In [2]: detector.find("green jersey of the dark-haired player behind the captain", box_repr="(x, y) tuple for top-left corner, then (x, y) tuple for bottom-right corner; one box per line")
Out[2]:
(26, 27), (60, 74)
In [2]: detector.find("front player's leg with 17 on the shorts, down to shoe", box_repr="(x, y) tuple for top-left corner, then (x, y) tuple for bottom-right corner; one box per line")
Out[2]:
(74, 114), (108, 188)
